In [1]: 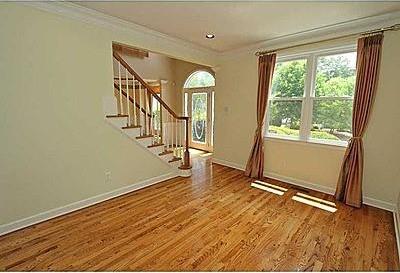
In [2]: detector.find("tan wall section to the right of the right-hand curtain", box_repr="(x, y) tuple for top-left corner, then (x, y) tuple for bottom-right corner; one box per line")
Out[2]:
(364, 31), (400, 204)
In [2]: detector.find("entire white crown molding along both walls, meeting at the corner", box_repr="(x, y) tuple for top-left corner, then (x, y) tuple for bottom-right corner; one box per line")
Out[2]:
(20, 1), (400, 65)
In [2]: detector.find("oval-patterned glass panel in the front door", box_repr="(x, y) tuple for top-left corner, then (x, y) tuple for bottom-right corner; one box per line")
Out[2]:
(192, 93), (207, 144)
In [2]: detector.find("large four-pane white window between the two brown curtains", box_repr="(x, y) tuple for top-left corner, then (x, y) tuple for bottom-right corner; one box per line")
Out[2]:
(267, 47), (356, 145)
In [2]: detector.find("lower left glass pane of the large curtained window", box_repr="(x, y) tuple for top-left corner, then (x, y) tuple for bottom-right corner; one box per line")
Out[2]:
(268, 101), (302, 137)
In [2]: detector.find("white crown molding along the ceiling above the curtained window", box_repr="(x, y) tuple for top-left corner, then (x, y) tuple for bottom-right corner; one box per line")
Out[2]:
(220, 11), (400, 59)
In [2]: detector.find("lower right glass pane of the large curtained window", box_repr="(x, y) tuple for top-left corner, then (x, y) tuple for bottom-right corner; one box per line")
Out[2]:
(311, 99), (353, 141)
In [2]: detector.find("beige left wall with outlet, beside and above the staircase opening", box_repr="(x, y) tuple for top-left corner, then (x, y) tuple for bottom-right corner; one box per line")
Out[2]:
(0, 3), (216, 225)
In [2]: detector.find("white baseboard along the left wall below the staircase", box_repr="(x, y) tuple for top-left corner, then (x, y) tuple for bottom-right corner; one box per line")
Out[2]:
(0, 172), (178, 236)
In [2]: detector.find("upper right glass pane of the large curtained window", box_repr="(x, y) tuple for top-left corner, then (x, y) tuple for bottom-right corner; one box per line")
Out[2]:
(315, 52), (357, 97)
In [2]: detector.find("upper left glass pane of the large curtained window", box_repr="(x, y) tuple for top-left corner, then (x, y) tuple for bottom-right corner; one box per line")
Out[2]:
(271, 59), (307, 98)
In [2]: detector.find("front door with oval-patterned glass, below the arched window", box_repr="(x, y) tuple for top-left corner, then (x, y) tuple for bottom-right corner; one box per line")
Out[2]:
(185, 87), (214, 152)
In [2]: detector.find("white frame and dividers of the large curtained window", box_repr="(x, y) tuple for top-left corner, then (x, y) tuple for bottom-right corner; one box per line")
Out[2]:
(265, 44), (357, 147)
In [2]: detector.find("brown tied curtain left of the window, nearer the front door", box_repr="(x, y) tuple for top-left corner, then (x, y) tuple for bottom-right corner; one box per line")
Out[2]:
(245, 54), (276, 178)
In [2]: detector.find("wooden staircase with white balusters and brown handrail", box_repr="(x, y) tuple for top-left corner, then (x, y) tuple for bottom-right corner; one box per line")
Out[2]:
(106, 52), (191, 177)
